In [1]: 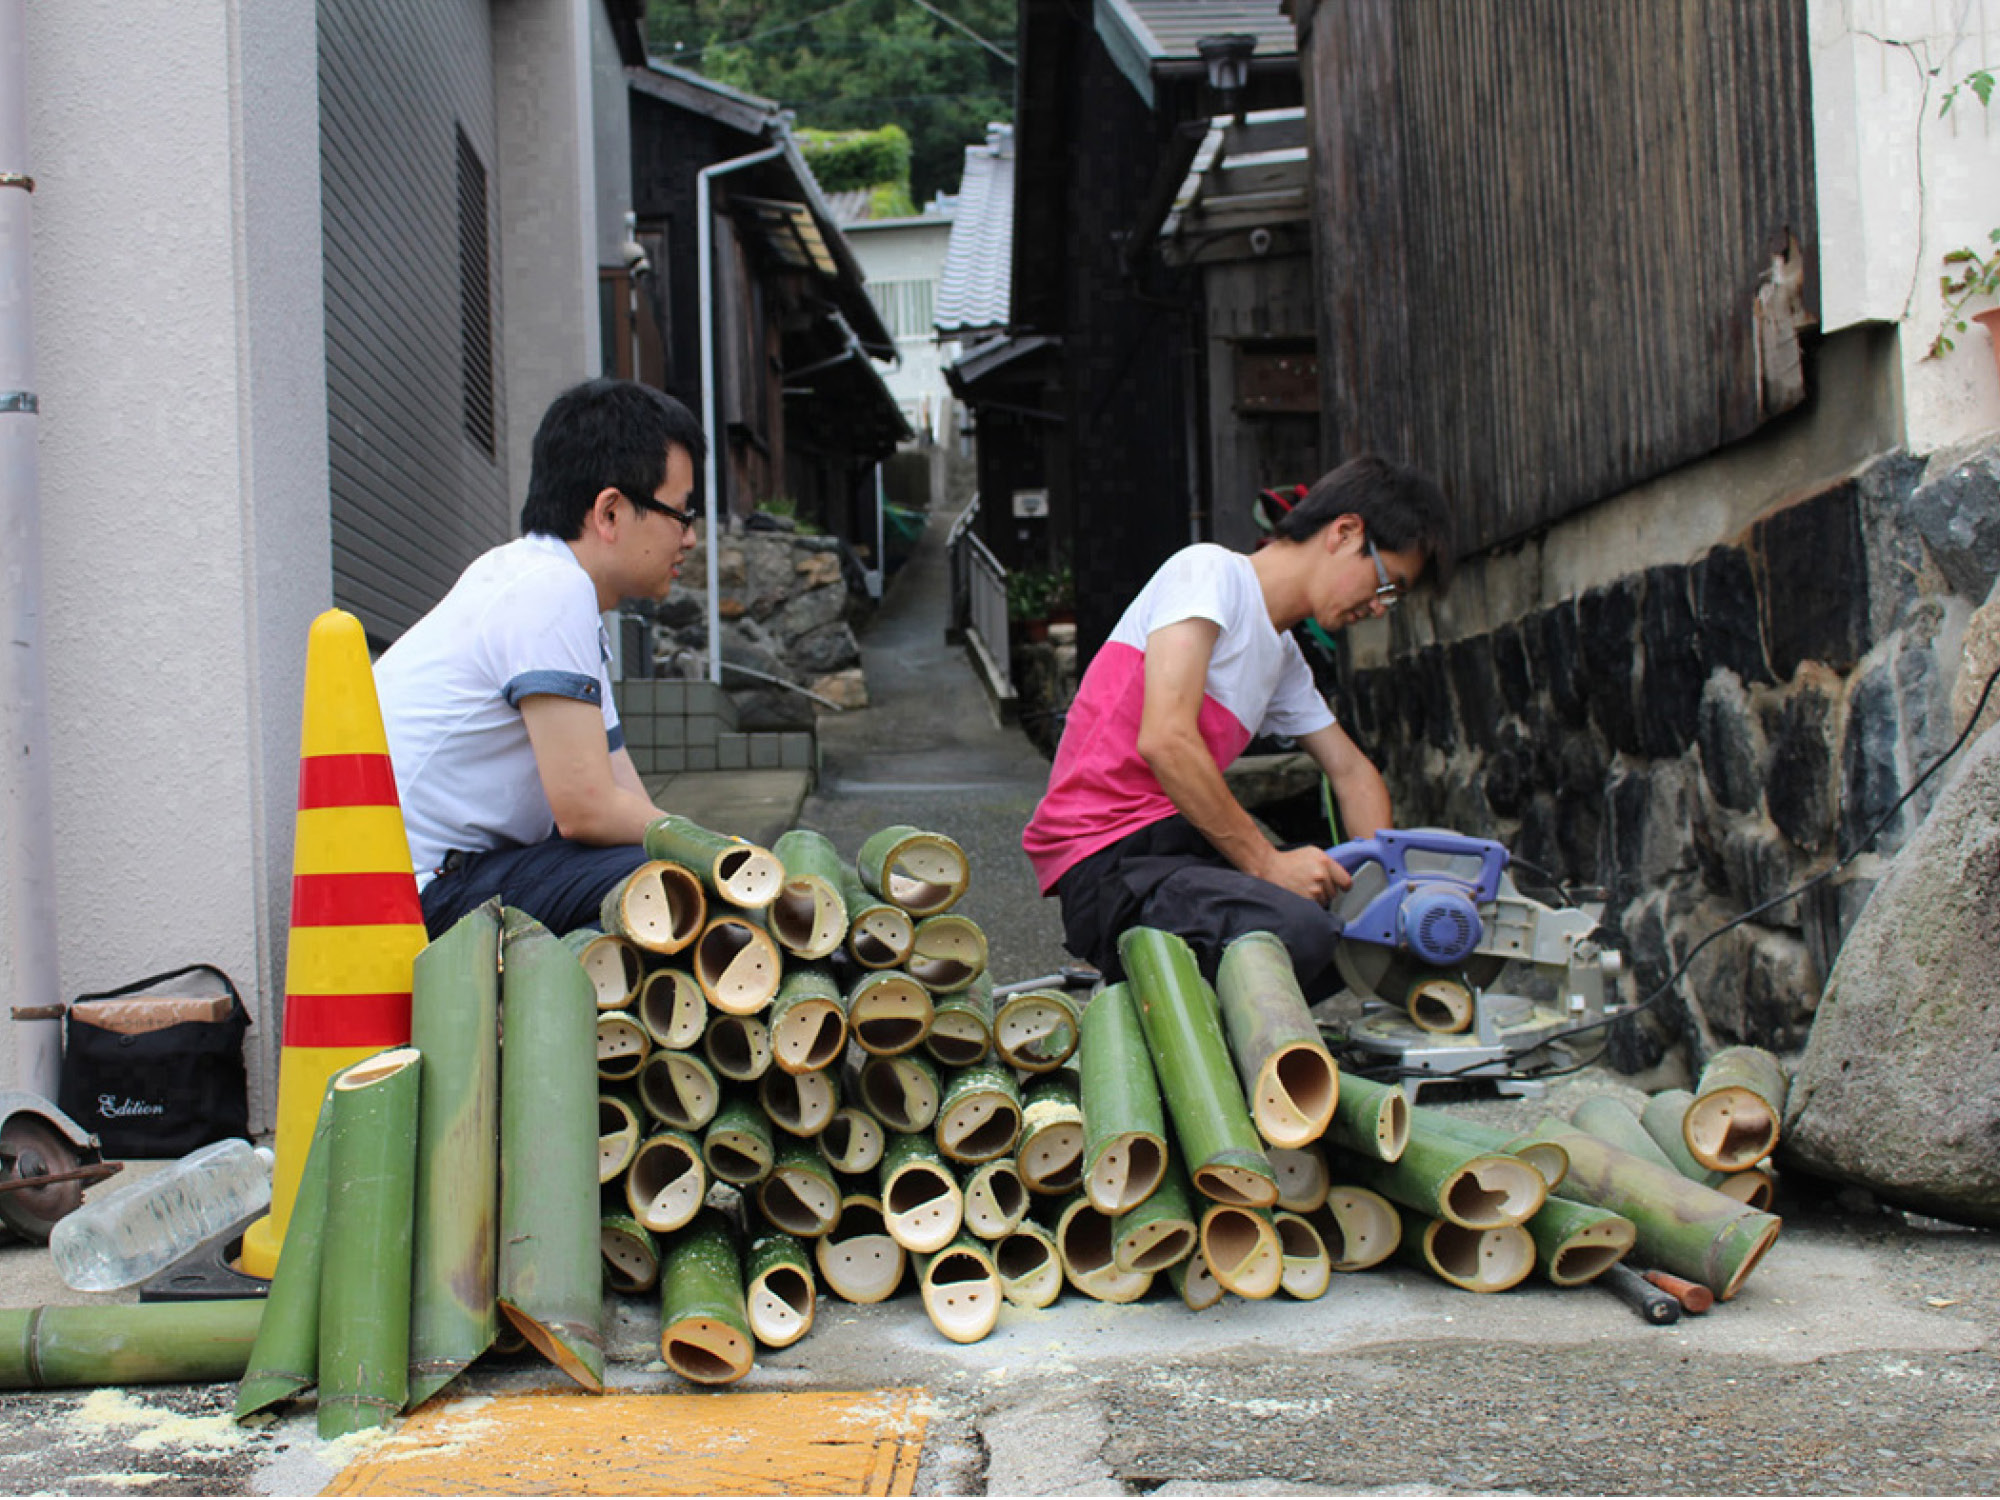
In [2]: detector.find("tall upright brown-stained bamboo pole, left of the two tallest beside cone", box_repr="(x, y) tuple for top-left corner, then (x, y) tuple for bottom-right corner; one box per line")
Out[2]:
(410, 902), (500, 1406)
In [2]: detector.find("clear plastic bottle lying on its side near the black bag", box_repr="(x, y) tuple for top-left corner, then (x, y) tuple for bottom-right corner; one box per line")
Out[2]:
(48, 1140), (272, 1292)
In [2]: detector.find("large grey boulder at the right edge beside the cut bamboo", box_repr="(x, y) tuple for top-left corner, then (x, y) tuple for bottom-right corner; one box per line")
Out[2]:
(1782, 728), (2000, 1226)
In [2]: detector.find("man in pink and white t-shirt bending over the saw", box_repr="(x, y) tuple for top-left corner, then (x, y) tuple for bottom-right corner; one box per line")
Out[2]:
(1022, 456), (1452, 998)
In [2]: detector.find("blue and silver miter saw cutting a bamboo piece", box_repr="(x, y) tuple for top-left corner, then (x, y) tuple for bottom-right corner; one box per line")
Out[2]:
(1328, 828), (1630, 1098)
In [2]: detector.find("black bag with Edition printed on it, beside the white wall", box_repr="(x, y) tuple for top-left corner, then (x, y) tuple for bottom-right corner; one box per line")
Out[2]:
(56, 964), (250, 1158)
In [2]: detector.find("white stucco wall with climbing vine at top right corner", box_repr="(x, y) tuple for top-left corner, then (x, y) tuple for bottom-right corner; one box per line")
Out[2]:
(1808, 0), (2000, 452)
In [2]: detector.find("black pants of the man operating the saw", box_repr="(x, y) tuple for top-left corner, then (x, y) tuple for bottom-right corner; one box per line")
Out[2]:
(1056, 814), (1342, 1000)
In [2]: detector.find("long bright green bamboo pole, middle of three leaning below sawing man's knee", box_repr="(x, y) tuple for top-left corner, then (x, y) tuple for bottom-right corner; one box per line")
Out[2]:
(1118, 928), (1278, 1208)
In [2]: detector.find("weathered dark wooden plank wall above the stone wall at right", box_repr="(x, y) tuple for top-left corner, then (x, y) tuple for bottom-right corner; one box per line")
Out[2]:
(1298, 0), (1818, 552)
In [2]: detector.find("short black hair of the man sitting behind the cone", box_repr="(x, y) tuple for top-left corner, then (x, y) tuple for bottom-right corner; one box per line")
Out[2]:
(520, 380), (708, 542)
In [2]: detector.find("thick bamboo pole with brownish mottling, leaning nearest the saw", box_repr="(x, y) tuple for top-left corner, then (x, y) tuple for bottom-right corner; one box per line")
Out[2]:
(1216, 932), (1340, 1148)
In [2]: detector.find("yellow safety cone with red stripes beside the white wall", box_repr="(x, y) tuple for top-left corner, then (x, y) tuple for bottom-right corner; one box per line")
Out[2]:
(242, 610), (426, 1278)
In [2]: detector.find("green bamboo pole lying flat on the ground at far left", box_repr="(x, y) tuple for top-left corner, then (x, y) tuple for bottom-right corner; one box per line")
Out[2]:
(0, 1304), (266, 1416)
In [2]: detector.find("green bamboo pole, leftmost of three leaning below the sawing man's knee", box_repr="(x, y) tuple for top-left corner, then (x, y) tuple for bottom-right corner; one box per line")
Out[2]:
(1078, 984), (1166, 1216)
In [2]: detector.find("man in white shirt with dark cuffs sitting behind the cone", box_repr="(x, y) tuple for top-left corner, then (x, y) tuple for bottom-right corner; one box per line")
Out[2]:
(376, 380), (706, 936)
